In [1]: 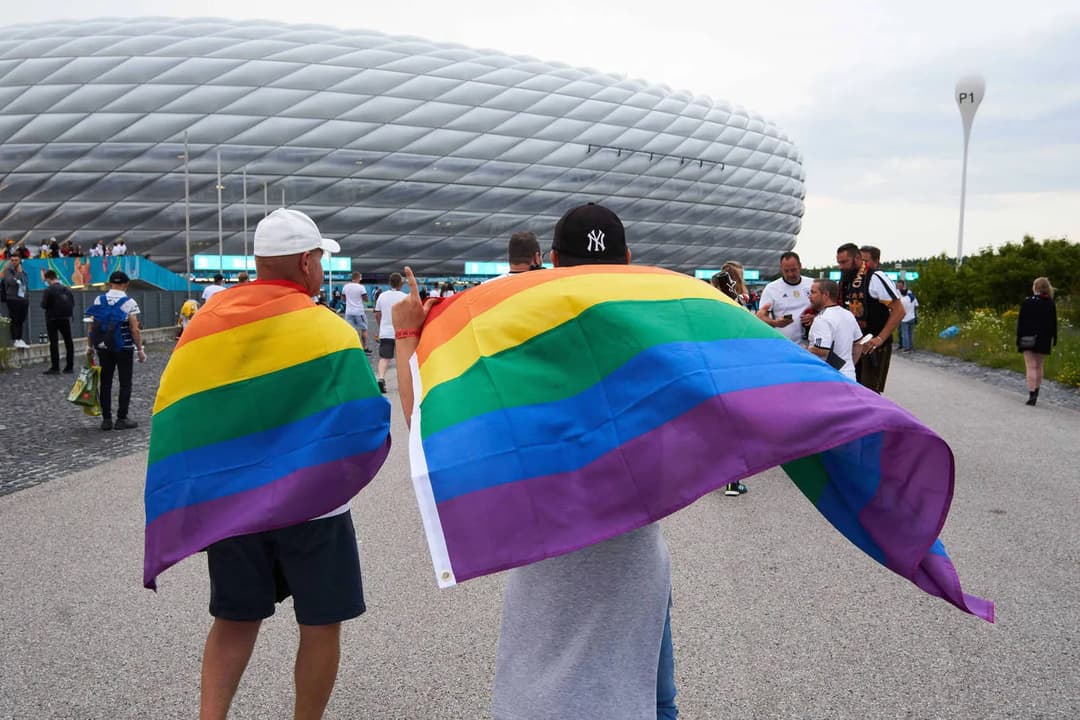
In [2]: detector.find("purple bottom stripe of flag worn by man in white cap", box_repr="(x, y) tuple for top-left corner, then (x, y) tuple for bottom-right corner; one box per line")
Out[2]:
(143, 436), (390, 589)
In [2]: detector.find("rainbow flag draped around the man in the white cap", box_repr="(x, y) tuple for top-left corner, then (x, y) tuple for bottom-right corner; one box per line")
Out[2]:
(143, 282), (390, 588)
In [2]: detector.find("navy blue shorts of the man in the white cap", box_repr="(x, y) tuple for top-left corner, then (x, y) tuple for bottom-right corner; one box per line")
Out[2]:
(206, 513), (365, 625)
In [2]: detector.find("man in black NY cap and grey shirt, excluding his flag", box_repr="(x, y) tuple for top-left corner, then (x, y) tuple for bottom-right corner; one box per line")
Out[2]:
(393, 203), (678, 720)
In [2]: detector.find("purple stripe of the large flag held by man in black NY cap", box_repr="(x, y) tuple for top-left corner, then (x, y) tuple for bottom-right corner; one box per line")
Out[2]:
(438, 382), (949, 581)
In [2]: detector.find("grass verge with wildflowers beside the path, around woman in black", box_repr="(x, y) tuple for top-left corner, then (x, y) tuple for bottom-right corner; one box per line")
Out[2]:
(915, 308), (1080, 388)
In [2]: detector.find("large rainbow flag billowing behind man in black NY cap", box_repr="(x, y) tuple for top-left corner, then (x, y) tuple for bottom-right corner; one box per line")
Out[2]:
(409, 266), (994, 622)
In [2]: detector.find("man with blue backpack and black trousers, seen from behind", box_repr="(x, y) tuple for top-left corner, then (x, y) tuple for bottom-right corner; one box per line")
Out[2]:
(86, 270), (146, 430)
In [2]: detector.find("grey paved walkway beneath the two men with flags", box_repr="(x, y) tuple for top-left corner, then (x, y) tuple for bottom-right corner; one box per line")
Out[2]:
(0, 357), (1080, 720)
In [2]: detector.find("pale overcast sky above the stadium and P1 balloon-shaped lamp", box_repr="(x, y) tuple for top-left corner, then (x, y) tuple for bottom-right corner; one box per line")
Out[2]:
(0, 0), (1080, 266)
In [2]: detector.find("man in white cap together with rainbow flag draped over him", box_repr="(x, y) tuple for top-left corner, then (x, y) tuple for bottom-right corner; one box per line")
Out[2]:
(144, 208), (390, 720)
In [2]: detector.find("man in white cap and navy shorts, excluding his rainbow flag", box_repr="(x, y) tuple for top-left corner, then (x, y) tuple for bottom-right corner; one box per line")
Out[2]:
(189, 208), (372, 720)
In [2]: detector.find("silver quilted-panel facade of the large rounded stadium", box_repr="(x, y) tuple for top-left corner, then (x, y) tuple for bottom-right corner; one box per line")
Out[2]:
(0, 18), (805, 274)
